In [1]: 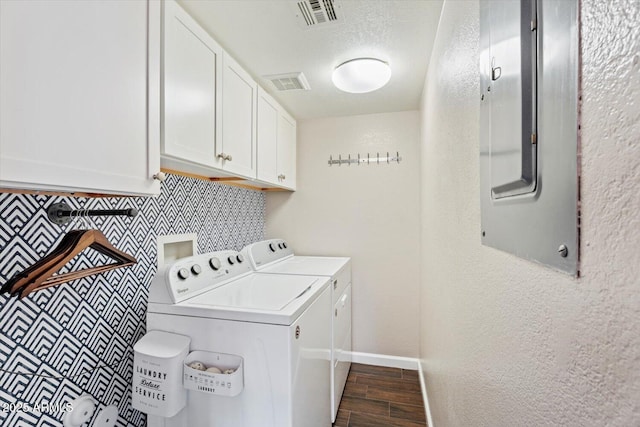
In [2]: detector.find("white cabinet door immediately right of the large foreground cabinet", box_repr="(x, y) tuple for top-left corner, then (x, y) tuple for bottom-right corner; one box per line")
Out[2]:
(162, 1), (222, 171)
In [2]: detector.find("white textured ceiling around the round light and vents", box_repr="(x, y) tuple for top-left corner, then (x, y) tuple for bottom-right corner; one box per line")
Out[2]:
(179, 0), (442, 119)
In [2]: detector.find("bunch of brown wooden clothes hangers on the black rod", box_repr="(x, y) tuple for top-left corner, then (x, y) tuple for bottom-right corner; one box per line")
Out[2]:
(1, 230), (138, 299)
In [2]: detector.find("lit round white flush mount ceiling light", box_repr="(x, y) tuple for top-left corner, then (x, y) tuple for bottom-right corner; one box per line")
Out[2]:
(331, 58), (391, 93)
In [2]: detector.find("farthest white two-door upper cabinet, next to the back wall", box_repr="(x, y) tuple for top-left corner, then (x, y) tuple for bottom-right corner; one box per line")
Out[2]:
(257, 88), (296, 190)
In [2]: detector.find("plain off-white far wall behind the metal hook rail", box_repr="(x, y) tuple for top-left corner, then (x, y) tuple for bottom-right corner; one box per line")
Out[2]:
(266, 111), (420, 357)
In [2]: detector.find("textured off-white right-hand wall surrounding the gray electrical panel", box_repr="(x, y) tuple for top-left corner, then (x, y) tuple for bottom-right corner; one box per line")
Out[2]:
(420, 0), (640, 427)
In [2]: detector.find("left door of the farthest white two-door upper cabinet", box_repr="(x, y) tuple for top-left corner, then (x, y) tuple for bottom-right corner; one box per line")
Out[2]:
(257, 88), (280, 184)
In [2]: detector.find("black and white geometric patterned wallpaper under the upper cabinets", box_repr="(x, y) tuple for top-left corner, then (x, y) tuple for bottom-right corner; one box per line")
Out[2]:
(0, 175), (265, 427)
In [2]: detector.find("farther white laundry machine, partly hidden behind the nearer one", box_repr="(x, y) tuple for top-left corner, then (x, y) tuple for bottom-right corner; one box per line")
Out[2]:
(241, 239), (351, 422)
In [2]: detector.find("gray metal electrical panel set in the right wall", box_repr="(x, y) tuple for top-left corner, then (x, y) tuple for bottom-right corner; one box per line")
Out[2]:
(480, 0), (579, 275)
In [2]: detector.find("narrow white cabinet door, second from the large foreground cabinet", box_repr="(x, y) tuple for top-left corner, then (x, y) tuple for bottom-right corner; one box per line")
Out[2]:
(221, 54), (258, 178)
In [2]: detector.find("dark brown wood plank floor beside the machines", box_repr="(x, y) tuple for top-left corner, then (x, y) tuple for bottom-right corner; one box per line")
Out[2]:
(333, 363), (427, 427)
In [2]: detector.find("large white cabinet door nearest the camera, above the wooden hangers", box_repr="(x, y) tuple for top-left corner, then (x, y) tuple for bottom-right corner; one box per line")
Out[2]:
(0, 1), (160, 194)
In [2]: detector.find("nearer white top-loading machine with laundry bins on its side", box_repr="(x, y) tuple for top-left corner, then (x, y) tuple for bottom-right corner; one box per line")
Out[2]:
(143, 251), (331, 427)
